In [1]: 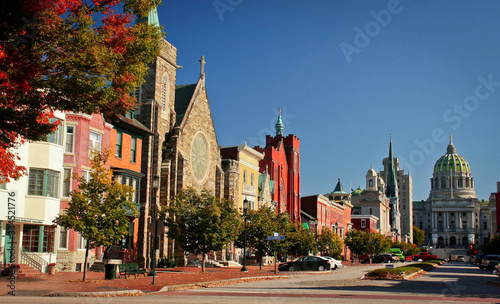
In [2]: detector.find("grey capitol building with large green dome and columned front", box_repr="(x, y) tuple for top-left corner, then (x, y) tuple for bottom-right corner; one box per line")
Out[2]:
(413, 136), (489, 248)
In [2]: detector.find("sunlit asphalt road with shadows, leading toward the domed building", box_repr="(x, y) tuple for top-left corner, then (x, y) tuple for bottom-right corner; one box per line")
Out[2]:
(0, 263), (500, 304)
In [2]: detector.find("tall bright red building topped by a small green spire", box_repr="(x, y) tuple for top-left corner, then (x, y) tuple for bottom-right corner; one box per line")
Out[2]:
(254, 110), (301, 221)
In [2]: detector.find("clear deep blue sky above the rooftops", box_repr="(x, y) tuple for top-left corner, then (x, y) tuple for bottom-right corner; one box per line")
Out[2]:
(158, 0), (500, 200)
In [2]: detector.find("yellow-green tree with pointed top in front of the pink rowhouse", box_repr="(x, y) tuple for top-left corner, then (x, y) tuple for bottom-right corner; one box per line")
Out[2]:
(54, 150), (137, 281)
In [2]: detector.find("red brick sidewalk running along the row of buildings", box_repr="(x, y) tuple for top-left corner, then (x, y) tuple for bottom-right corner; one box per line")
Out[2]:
(0, 265), (289, 296)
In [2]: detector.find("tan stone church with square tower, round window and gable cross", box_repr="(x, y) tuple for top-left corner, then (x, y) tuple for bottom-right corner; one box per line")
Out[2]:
(134, 10), (224, 266)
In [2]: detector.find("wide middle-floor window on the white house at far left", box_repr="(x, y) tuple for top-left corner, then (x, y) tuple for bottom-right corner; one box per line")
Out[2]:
(28, 169), (59, 198)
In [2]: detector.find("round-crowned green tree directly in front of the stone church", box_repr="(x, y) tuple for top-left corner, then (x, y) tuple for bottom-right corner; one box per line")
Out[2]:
(166, 188), (239, 272)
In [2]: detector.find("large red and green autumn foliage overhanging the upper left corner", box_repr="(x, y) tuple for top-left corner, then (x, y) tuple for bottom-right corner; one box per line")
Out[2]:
(0, 0), (162, 182)
